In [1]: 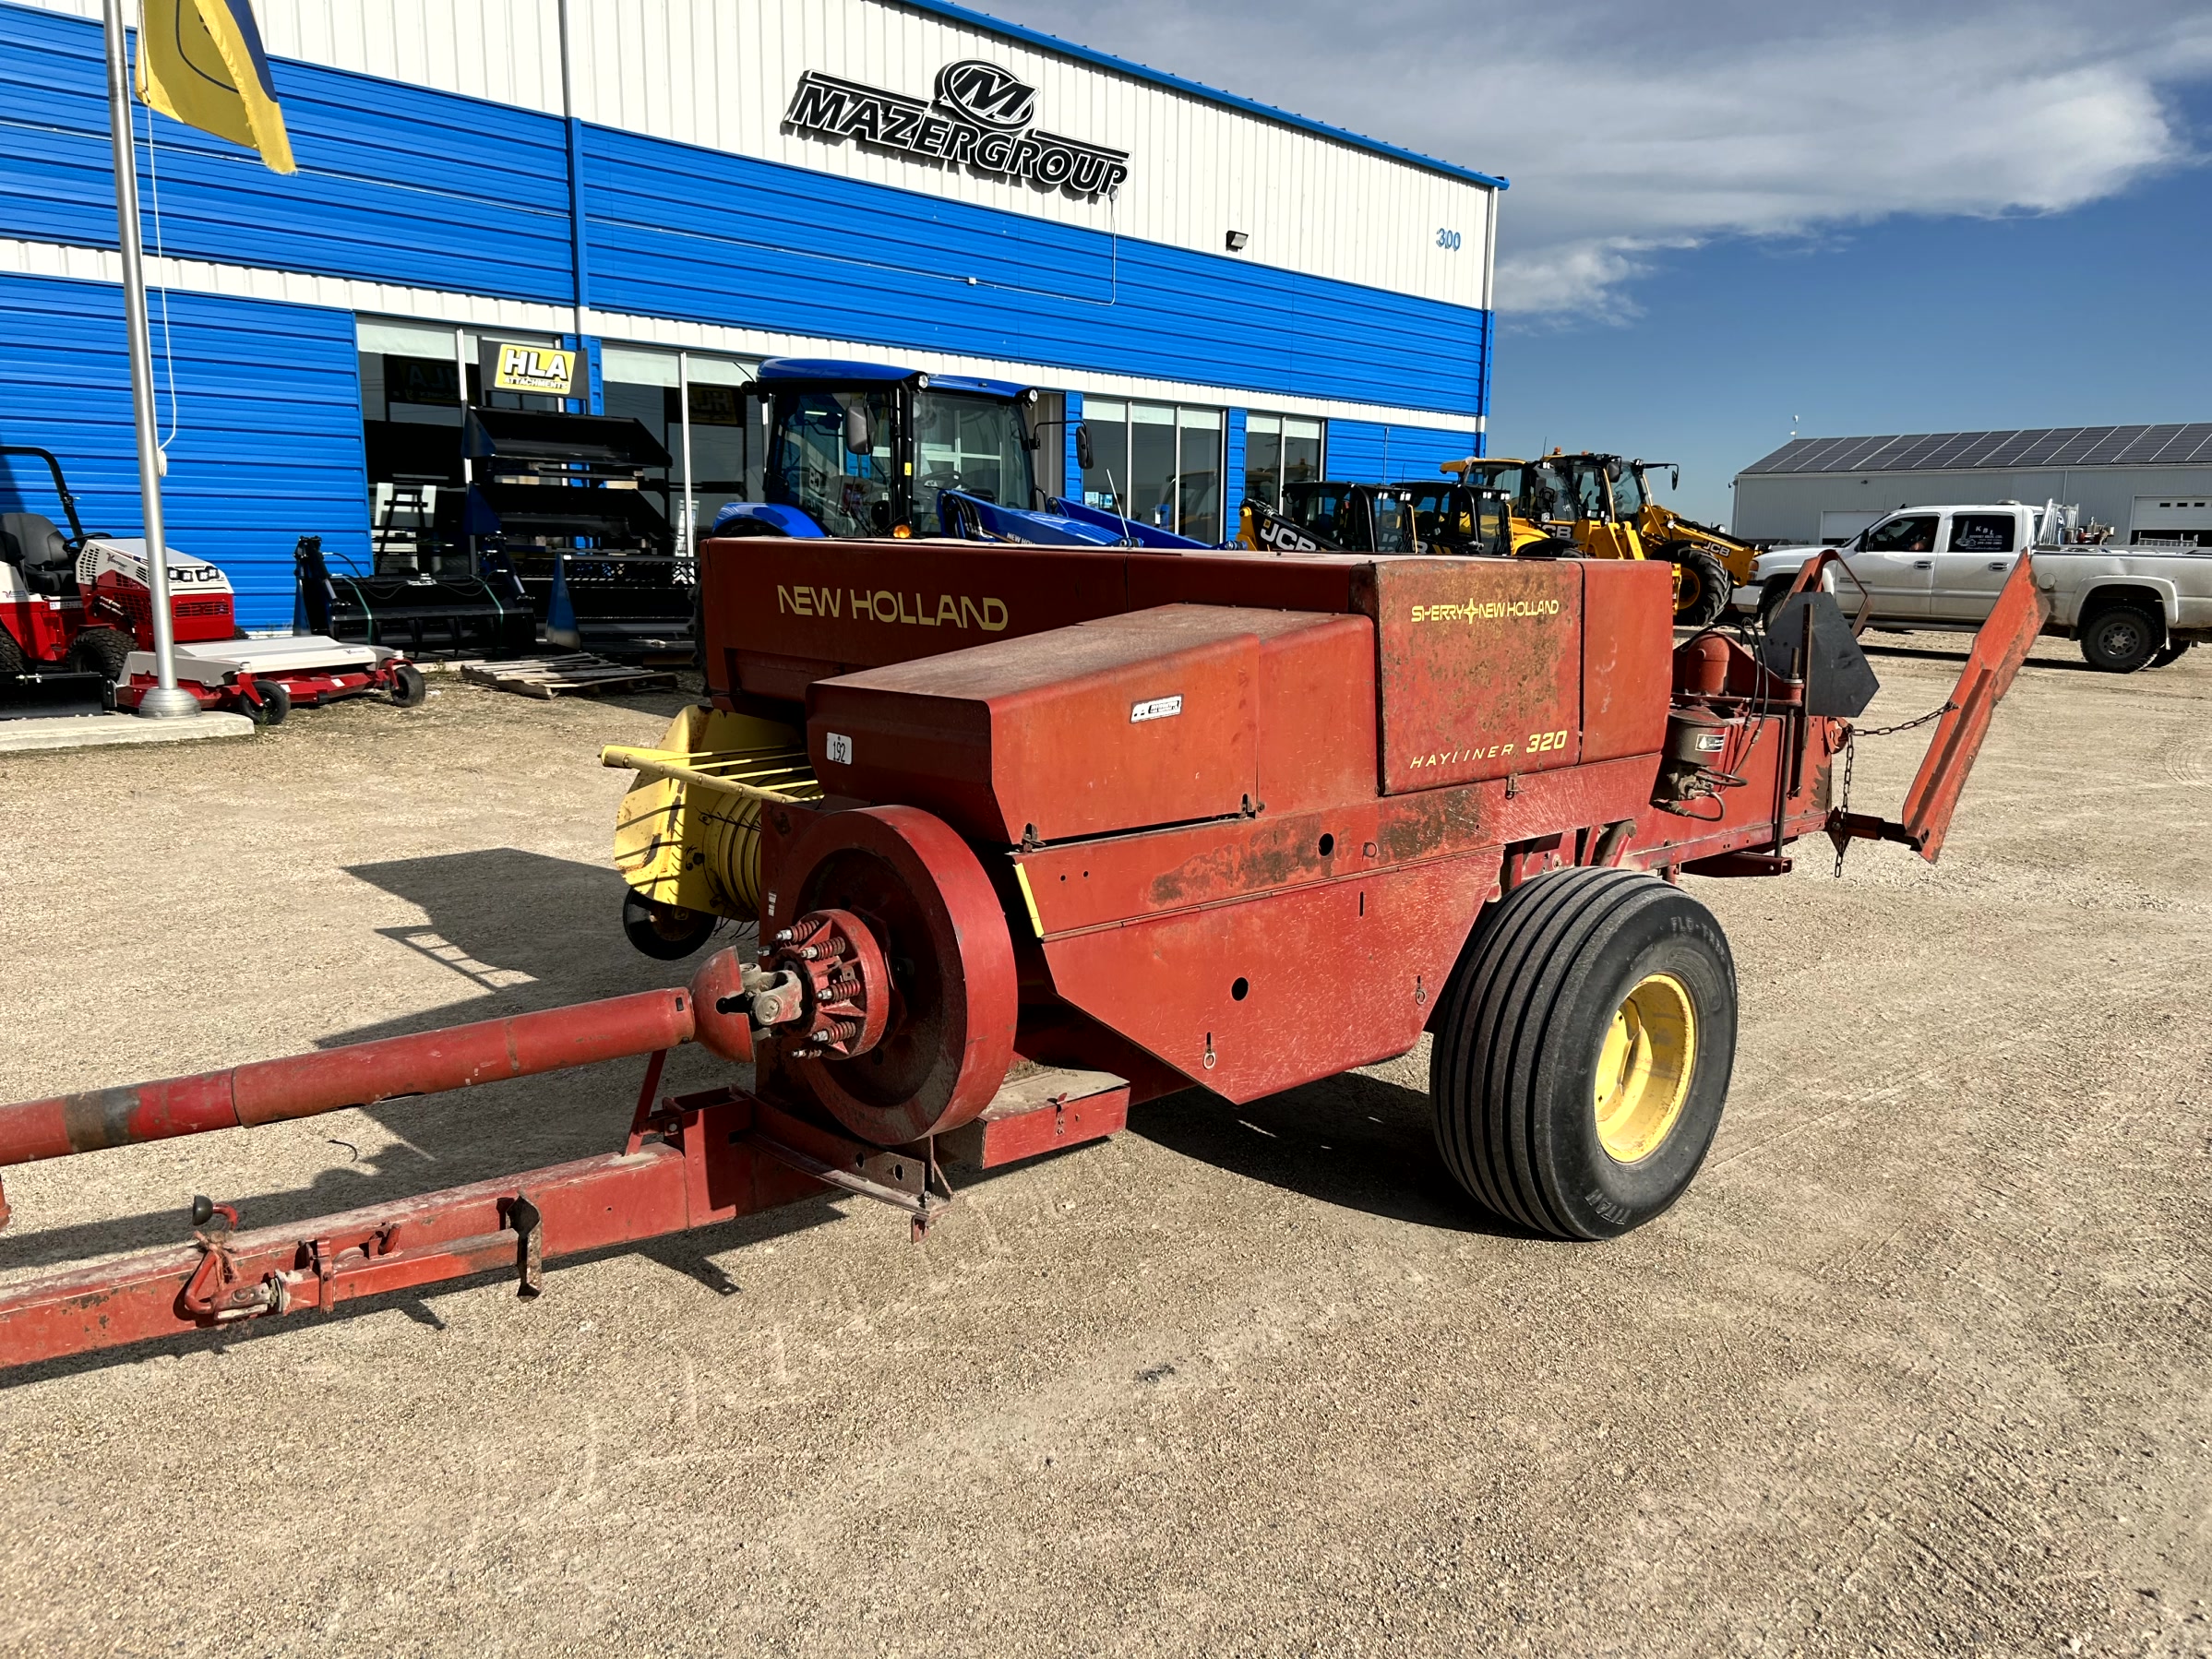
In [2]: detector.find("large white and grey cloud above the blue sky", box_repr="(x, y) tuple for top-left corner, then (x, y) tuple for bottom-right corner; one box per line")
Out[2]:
(988, 0), (2212, 316)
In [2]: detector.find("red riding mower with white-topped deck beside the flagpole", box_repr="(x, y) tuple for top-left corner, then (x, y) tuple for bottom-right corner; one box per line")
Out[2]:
(0, 445), (429, 725)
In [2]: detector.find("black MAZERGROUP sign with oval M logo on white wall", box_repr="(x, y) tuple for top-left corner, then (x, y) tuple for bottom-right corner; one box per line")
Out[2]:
(783, 57), (1128, 197)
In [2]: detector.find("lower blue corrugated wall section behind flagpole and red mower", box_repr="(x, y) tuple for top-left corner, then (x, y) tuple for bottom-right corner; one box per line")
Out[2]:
(0, 274), (369, 628)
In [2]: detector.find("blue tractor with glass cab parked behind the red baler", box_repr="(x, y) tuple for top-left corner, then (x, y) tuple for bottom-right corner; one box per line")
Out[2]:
(714, 358), (1210, 551)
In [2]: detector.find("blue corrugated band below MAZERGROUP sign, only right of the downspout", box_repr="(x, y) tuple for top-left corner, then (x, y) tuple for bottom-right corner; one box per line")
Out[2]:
(584, 126), (1489, 416)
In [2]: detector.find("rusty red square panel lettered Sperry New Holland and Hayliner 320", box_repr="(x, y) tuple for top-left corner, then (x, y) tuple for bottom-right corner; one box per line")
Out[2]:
(1367, 560), (1582, 794)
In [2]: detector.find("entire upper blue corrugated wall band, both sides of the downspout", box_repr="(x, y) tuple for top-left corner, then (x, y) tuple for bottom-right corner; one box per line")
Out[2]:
(0, 2), (1491, 416)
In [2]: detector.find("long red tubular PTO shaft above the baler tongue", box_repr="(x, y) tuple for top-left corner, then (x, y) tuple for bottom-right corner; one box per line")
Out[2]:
(0, 951), (763, 1165)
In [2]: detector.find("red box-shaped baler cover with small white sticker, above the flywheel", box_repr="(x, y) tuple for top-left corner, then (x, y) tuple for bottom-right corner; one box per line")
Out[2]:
(807, 606), (1265, 842)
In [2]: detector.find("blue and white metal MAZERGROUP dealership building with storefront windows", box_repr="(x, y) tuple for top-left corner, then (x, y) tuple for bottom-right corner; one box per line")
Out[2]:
(0, 0), (1502, 628)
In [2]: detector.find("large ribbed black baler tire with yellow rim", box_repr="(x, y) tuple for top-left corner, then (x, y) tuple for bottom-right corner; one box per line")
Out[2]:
(1429, 869), (1737, 1239)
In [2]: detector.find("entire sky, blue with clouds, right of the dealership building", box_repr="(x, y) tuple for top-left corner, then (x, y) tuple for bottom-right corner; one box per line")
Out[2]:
(985, 0), (2212, 522)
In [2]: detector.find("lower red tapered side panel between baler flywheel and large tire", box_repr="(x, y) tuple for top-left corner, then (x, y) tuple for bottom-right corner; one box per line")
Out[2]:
(1044, 847), (1498, 1099)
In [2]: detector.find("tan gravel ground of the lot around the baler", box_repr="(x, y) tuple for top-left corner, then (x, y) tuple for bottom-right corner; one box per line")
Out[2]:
(0, 637), (2212, 1657)
